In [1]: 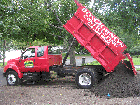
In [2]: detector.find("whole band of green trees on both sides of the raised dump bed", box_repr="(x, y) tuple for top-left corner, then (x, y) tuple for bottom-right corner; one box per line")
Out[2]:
(0, 0), (140, 65)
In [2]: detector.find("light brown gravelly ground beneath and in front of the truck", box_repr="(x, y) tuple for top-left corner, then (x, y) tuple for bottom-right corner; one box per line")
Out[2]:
(0, 72), (140, 105)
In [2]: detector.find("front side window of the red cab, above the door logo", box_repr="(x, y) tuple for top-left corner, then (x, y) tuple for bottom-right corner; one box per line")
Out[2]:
(22, 48), (35, 59)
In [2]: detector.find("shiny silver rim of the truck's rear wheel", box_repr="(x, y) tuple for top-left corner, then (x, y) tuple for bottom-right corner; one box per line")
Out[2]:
(79, 73), (91, 85)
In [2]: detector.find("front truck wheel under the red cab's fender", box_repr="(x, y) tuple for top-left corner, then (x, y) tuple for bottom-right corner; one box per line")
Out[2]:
(6, 71), (20, 86)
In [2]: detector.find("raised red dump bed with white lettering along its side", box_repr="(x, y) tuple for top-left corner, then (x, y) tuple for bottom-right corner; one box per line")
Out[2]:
(64, 1), (135, 72)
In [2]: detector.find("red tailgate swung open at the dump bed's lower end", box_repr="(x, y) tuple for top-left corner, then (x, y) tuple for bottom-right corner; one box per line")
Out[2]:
(122, 53), (137, 76)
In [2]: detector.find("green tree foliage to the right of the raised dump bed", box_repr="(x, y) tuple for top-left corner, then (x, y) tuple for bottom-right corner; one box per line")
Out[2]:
(91, 0), (140, 51)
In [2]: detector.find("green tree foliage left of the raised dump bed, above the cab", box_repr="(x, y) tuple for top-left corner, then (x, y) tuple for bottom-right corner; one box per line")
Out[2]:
(0, 0), (90, 65)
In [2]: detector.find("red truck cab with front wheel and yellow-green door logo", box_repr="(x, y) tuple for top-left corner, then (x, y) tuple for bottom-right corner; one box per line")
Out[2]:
(3, 46), (62, 85)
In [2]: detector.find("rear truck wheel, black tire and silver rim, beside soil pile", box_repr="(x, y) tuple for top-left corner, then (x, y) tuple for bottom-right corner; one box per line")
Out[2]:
(75, 70), (94, 89)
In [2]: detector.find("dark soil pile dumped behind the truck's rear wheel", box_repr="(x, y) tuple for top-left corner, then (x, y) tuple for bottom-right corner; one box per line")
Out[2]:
(91, 63), (140, 98)
